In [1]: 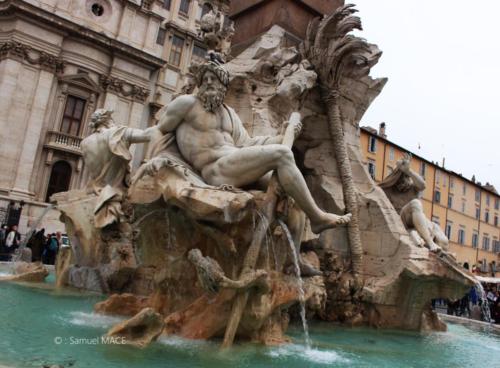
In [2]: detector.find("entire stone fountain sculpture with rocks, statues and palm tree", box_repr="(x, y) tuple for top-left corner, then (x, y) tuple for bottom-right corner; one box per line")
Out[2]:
(46, 5), (474, 346)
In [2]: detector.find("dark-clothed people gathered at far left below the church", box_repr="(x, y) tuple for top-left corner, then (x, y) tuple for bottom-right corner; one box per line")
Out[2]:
(0, 225), (63, 265)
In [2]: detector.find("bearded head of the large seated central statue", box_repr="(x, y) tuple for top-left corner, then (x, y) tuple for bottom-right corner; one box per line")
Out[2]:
(197, 61), (229, 112)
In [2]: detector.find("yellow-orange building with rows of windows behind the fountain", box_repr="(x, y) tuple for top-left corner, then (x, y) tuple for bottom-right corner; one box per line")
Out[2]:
(360, 123), (500, 275)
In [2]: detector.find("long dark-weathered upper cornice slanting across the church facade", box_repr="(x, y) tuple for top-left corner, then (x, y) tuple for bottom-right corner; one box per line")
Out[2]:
(0, 0), (165, 69)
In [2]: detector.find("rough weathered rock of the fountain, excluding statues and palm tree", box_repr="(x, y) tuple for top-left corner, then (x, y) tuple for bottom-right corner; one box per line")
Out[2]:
(51, 27), (472, 343)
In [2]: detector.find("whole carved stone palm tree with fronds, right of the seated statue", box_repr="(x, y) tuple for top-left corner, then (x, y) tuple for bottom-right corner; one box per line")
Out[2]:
(301, 5), (370, 276)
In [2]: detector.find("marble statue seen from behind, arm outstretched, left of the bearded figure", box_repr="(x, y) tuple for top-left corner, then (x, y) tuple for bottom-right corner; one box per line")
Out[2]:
(81, 109), (150, 228)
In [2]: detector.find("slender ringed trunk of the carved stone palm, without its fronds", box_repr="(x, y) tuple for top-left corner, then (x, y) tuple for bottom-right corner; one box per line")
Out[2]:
(321, 86), (363, 276)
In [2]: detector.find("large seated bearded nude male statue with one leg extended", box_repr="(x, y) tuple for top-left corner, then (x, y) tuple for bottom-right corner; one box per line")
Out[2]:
(141, 61), (351, 233)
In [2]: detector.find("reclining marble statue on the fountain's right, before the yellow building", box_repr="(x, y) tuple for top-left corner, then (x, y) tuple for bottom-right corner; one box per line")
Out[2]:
(380, 155), (448, 252)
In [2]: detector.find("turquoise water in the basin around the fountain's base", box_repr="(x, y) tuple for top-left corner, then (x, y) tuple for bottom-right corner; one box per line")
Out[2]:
(0, 276), (500, 368)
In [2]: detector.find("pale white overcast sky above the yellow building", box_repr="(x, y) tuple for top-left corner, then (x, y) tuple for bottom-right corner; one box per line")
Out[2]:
(354, 0), (500, 191)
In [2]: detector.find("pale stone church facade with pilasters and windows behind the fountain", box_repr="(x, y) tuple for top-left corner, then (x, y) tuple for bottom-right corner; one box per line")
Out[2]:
(0, 0), (229, 233)
